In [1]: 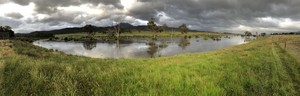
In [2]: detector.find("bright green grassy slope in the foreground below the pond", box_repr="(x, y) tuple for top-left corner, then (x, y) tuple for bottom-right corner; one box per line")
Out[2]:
(0, 36), (300, 96)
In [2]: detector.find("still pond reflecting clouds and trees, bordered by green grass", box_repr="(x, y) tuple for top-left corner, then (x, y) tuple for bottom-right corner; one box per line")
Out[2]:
(33, 36), (253, 58)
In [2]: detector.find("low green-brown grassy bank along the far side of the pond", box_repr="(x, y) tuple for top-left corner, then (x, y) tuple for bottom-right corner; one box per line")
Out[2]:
(50, 32), (232, 41)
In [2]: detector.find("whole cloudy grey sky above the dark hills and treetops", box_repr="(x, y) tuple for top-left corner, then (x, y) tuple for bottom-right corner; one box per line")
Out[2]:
(0, 0), (300, 33)
